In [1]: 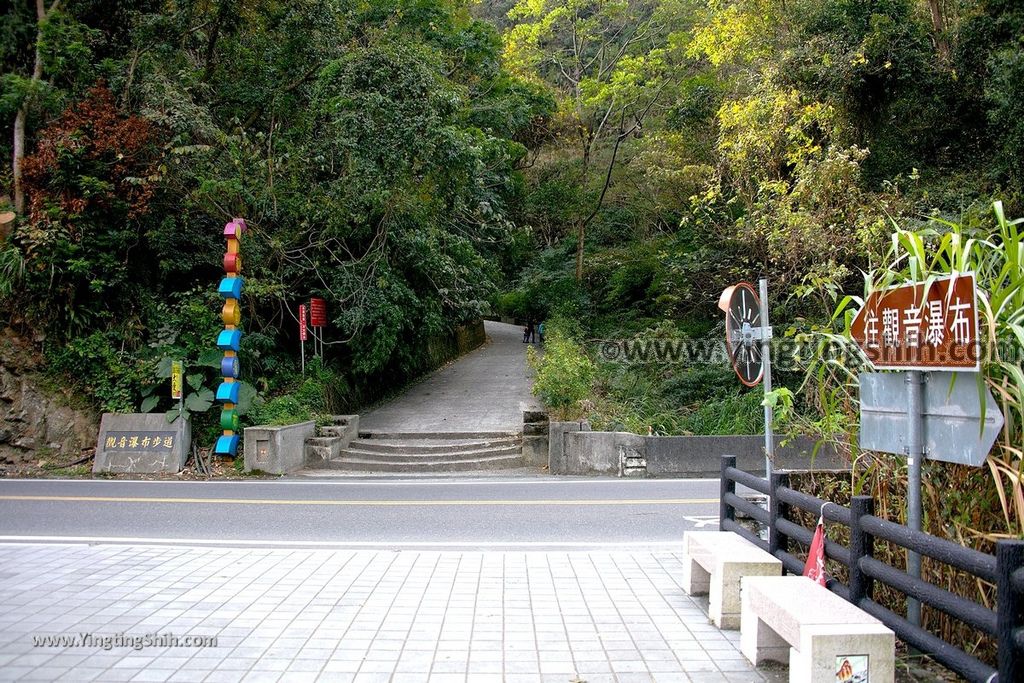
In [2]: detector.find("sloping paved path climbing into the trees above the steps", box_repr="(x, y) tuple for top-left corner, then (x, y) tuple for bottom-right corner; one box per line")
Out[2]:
(359, 321), (536, 432)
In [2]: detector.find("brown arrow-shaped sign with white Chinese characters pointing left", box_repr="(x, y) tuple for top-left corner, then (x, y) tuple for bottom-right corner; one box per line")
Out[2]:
(850, 273), (981, 371)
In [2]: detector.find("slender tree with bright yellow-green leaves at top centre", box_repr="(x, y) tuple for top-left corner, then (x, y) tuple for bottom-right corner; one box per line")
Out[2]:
(505, 0), (673, 280)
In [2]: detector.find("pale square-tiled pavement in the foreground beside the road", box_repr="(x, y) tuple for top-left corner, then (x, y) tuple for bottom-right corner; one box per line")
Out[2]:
(0, 544), (774, 683)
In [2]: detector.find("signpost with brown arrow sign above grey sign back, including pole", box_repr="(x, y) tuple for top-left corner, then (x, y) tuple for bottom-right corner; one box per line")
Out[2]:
(850, 272), (987, 626)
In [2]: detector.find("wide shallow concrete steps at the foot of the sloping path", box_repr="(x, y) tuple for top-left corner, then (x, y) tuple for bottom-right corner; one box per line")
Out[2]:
(317, 427), (524, 472)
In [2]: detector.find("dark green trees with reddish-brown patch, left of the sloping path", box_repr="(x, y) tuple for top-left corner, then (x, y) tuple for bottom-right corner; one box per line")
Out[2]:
(0, 0), (553, 438)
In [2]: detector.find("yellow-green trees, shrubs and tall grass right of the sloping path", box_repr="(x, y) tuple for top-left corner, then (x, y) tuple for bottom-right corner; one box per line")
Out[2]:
(489, 0), (1024, 656)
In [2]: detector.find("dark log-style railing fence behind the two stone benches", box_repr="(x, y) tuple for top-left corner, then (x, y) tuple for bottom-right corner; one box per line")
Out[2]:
(719, 456), (1024, 683)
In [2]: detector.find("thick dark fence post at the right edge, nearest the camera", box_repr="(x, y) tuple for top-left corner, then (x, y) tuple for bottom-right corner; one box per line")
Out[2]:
(995, 541), (1024, 683)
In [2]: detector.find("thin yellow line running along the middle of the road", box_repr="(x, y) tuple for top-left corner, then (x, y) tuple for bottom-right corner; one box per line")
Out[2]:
(0, 496), (719, 507)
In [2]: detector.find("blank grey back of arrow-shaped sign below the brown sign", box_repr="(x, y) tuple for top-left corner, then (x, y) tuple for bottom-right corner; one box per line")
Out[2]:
(860, 372), (1002, 467)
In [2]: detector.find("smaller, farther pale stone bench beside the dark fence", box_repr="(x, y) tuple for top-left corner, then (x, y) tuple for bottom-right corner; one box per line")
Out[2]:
(683, 531), (782, 629)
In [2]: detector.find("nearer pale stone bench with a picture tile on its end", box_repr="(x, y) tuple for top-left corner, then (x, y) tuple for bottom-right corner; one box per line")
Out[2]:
(739, 577), (896, 683)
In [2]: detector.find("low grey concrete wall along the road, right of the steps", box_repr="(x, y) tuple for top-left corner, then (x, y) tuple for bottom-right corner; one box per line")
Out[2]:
(548, 430), (845, 477)
